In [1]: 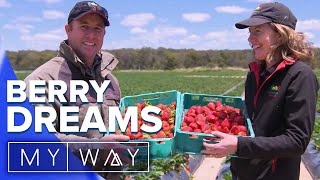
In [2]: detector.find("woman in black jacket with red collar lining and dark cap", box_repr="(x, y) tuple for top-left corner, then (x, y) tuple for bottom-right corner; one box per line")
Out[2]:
(202, 3), (319, 180)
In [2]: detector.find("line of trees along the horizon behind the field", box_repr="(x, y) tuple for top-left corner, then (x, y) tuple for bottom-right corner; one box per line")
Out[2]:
(7, 47), (320, 70)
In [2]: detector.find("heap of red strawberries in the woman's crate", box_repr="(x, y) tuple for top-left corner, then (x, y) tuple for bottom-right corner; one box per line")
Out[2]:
(181, 101), (247, 136)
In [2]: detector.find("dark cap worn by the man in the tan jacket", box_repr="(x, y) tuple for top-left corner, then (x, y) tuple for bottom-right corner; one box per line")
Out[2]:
(68, 1), (110, 26)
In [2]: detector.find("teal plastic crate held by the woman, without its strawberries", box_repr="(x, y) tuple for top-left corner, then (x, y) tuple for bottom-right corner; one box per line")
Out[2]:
(176, 93), (255, 157)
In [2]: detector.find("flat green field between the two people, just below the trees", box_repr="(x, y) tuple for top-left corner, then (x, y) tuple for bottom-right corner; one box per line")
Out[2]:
(16, 70), (246, 96)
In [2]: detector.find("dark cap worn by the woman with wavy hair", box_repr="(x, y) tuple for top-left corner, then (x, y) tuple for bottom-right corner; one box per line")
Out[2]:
(235, 2), (297, 29)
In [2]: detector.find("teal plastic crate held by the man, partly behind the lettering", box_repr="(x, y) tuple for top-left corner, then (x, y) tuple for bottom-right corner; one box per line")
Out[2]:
(120, 90), (182, 159)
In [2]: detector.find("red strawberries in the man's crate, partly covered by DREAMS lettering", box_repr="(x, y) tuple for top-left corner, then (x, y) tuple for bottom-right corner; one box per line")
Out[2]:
(116, 101), (177, 140)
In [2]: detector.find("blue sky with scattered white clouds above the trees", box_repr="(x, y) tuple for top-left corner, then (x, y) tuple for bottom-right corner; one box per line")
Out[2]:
(0, 0), (320, 51)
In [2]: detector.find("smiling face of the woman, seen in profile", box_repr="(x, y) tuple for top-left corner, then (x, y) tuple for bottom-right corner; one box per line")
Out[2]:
(248, 23), (280, 63)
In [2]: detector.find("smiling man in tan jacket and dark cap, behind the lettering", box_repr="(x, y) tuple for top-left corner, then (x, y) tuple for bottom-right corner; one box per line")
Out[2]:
(25, 1), (129, 177)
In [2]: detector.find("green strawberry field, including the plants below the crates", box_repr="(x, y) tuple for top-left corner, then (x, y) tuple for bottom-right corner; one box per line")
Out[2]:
(17, 69), (320, 178)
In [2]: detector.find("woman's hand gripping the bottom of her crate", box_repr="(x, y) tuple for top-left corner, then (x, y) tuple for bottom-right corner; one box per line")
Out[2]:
(201, 131), (238, 158)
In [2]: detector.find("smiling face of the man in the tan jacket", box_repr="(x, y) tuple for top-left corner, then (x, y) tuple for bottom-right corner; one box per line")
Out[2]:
(65, 13), (105, 67)
